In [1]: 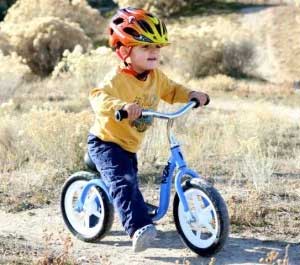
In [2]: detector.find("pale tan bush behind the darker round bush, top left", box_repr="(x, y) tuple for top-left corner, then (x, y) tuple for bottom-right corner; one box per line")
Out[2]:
(5, 0), (106, 41)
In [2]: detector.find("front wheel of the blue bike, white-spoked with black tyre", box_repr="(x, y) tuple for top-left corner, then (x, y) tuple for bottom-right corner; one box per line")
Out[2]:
(173, 179), (229, 257)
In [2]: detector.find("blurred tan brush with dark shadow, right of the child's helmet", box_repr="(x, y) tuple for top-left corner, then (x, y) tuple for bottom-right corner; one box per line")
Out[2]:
(164, 14), (260, 79)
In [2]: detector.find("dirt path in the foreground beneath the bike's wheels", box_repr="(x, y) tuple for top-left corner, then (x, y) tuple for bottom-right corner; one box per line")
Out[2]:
(0, 201), (300, 265)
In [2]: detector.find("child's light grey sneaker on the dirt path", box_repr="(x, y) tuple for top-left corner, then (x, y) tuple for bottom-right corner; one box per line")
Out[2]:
(132, 224), (157, 252)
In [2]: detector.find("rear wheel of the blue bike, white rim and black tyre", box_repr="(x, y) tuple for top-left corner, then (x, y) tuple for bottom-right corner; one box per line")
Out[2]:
(60, 171), (114, 242)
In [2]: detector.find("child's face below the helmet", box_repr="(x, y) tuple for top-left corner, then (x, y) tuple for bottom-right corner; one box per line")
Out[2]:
(129, 45), (161, 73)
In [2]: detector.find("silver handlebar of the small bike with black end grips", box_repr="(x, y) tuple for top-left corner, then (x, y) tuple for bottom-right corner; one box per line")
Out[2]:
(115, 98), (200, 121)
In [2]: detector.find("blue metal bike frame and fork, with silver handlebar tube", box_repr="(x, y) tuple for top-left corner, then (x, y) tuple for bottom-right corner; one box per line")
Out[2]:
(76, 102), (200, 222)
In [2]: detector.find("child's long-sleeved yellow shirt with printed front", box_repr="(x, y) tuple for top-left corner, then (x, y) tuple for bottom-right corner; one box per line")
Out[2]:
(89, 69), (191, 153)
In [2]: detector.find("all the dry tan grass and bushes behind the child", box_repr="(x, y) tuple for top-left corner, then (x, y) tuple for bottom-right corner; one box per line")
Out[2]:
(0, 1), (300, 264)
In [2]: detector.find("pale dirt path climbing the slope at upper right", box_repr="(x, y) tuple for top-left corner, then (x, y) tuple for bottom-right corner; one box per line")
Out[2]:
(241, 5), (300, 83)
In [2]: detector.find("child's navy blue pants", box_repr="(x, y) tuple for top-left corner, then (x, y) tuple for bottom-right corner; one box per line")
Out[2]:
(88, 134), (152, 237)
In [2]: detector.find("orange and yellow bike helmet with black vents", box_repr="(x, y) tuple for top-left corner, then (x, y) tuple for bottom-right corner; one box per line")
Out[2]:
(109, 7), (169, 48)
